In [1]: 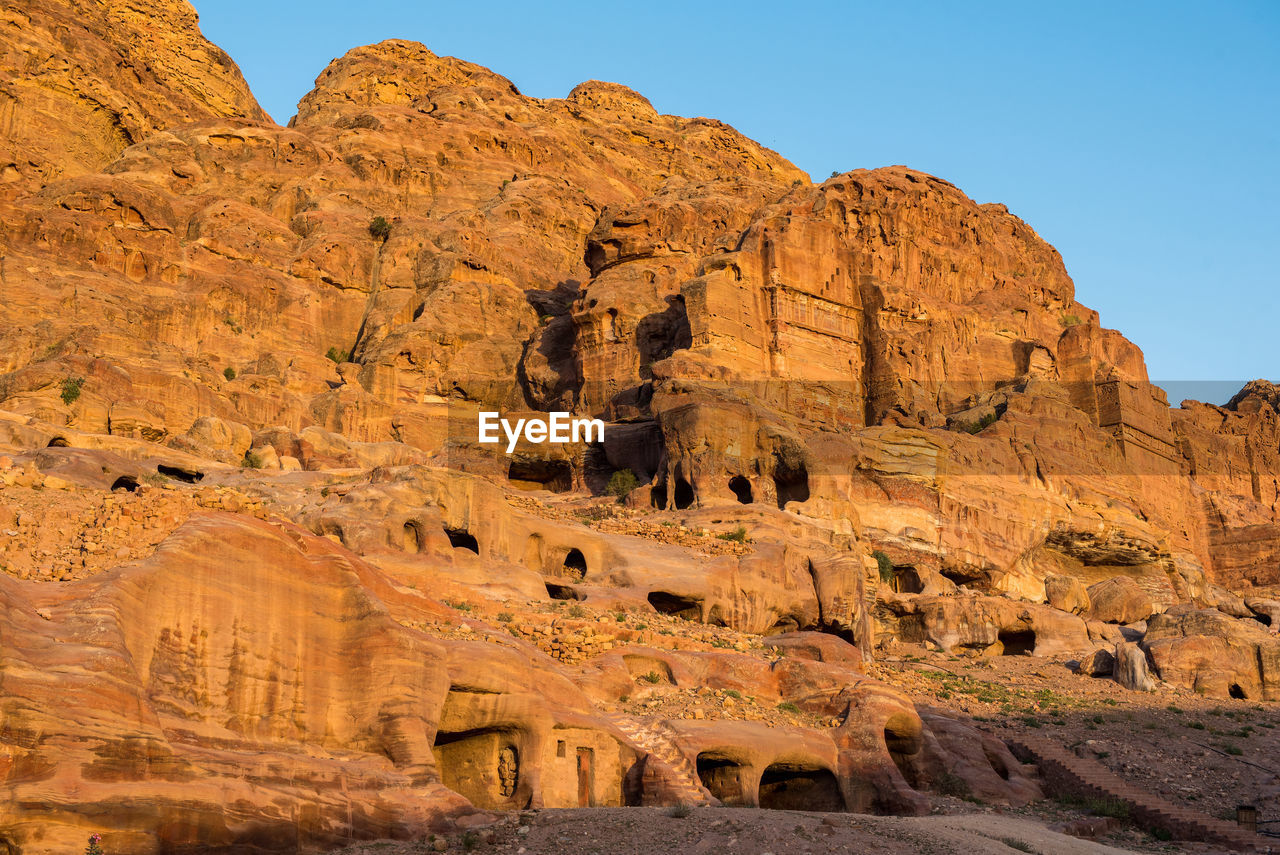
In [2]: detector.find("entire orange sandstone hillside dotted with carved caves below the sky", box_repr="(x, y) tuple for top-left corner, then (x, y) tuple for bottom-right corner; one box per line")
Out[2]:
(0, 0), (1280, 852)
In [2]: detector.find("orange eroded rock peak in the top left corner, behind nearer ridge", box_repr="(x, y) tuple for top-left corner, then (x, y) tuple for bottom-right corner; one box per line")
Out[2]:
(0, 0), (268, 186)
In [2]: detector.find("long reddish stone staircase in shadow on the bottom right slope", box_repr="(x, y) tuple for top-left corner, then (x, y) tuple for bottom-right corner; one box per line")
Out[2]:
(1005, 736), (1280, 852)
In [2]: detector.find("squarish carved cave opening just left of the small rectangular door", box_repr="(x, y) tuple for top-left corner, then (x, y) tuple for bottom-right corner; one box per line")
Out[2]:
(433, 728), (521, 810)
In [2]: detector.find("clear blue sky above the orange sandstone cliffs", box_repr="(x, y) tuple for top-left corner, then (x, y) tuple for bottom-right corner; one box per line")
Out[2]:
(195, 0), (1280, 399)
